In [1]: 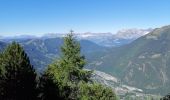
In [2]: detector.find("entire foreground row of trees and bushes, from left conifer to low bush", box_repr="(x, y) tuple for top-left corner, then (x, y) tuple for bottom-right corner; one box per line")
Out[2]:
(0, 33), (117, 100)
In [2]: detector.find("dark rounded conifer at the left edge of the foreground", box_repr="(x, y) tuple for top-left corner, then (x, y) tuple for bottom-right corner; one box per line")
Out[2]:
(0, 42), (37, 100)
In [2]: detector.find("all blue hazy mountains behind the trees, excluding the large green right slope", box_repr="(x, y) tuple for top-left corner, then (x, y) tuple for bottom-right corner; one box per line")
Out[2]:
(0, 29), (151, 72)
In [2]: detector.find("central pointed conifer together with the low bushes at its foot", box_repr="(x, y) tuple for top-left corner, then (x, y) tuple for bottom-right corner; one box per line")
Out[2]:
(40, 33), (116, 100)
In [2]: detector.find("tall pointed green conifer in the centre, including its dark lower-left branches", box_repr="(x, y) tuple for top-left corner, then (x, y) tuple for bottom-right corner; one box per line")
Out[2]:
(40, 31), (91, 100)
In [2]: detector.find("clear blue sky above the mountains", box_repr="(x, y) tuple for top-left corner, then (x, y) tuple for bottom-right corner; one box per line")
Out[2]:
(0, 0), (170, 36)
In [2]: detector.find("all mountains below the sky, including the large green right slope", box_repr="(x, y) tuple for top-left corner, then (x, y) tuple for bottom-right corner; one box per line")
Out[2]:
(0, 26), (170, 94)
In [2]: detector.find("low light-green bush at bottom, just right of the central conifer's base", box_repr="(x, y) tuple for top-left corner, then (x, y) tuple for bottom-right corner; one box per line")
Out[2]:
(78, 82), (117, 100)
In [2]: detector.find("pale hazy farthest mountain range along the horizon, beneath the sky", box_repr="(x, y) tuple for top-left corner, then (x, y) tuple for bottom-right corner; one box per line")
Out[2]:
(0, 29), (152, 47)
